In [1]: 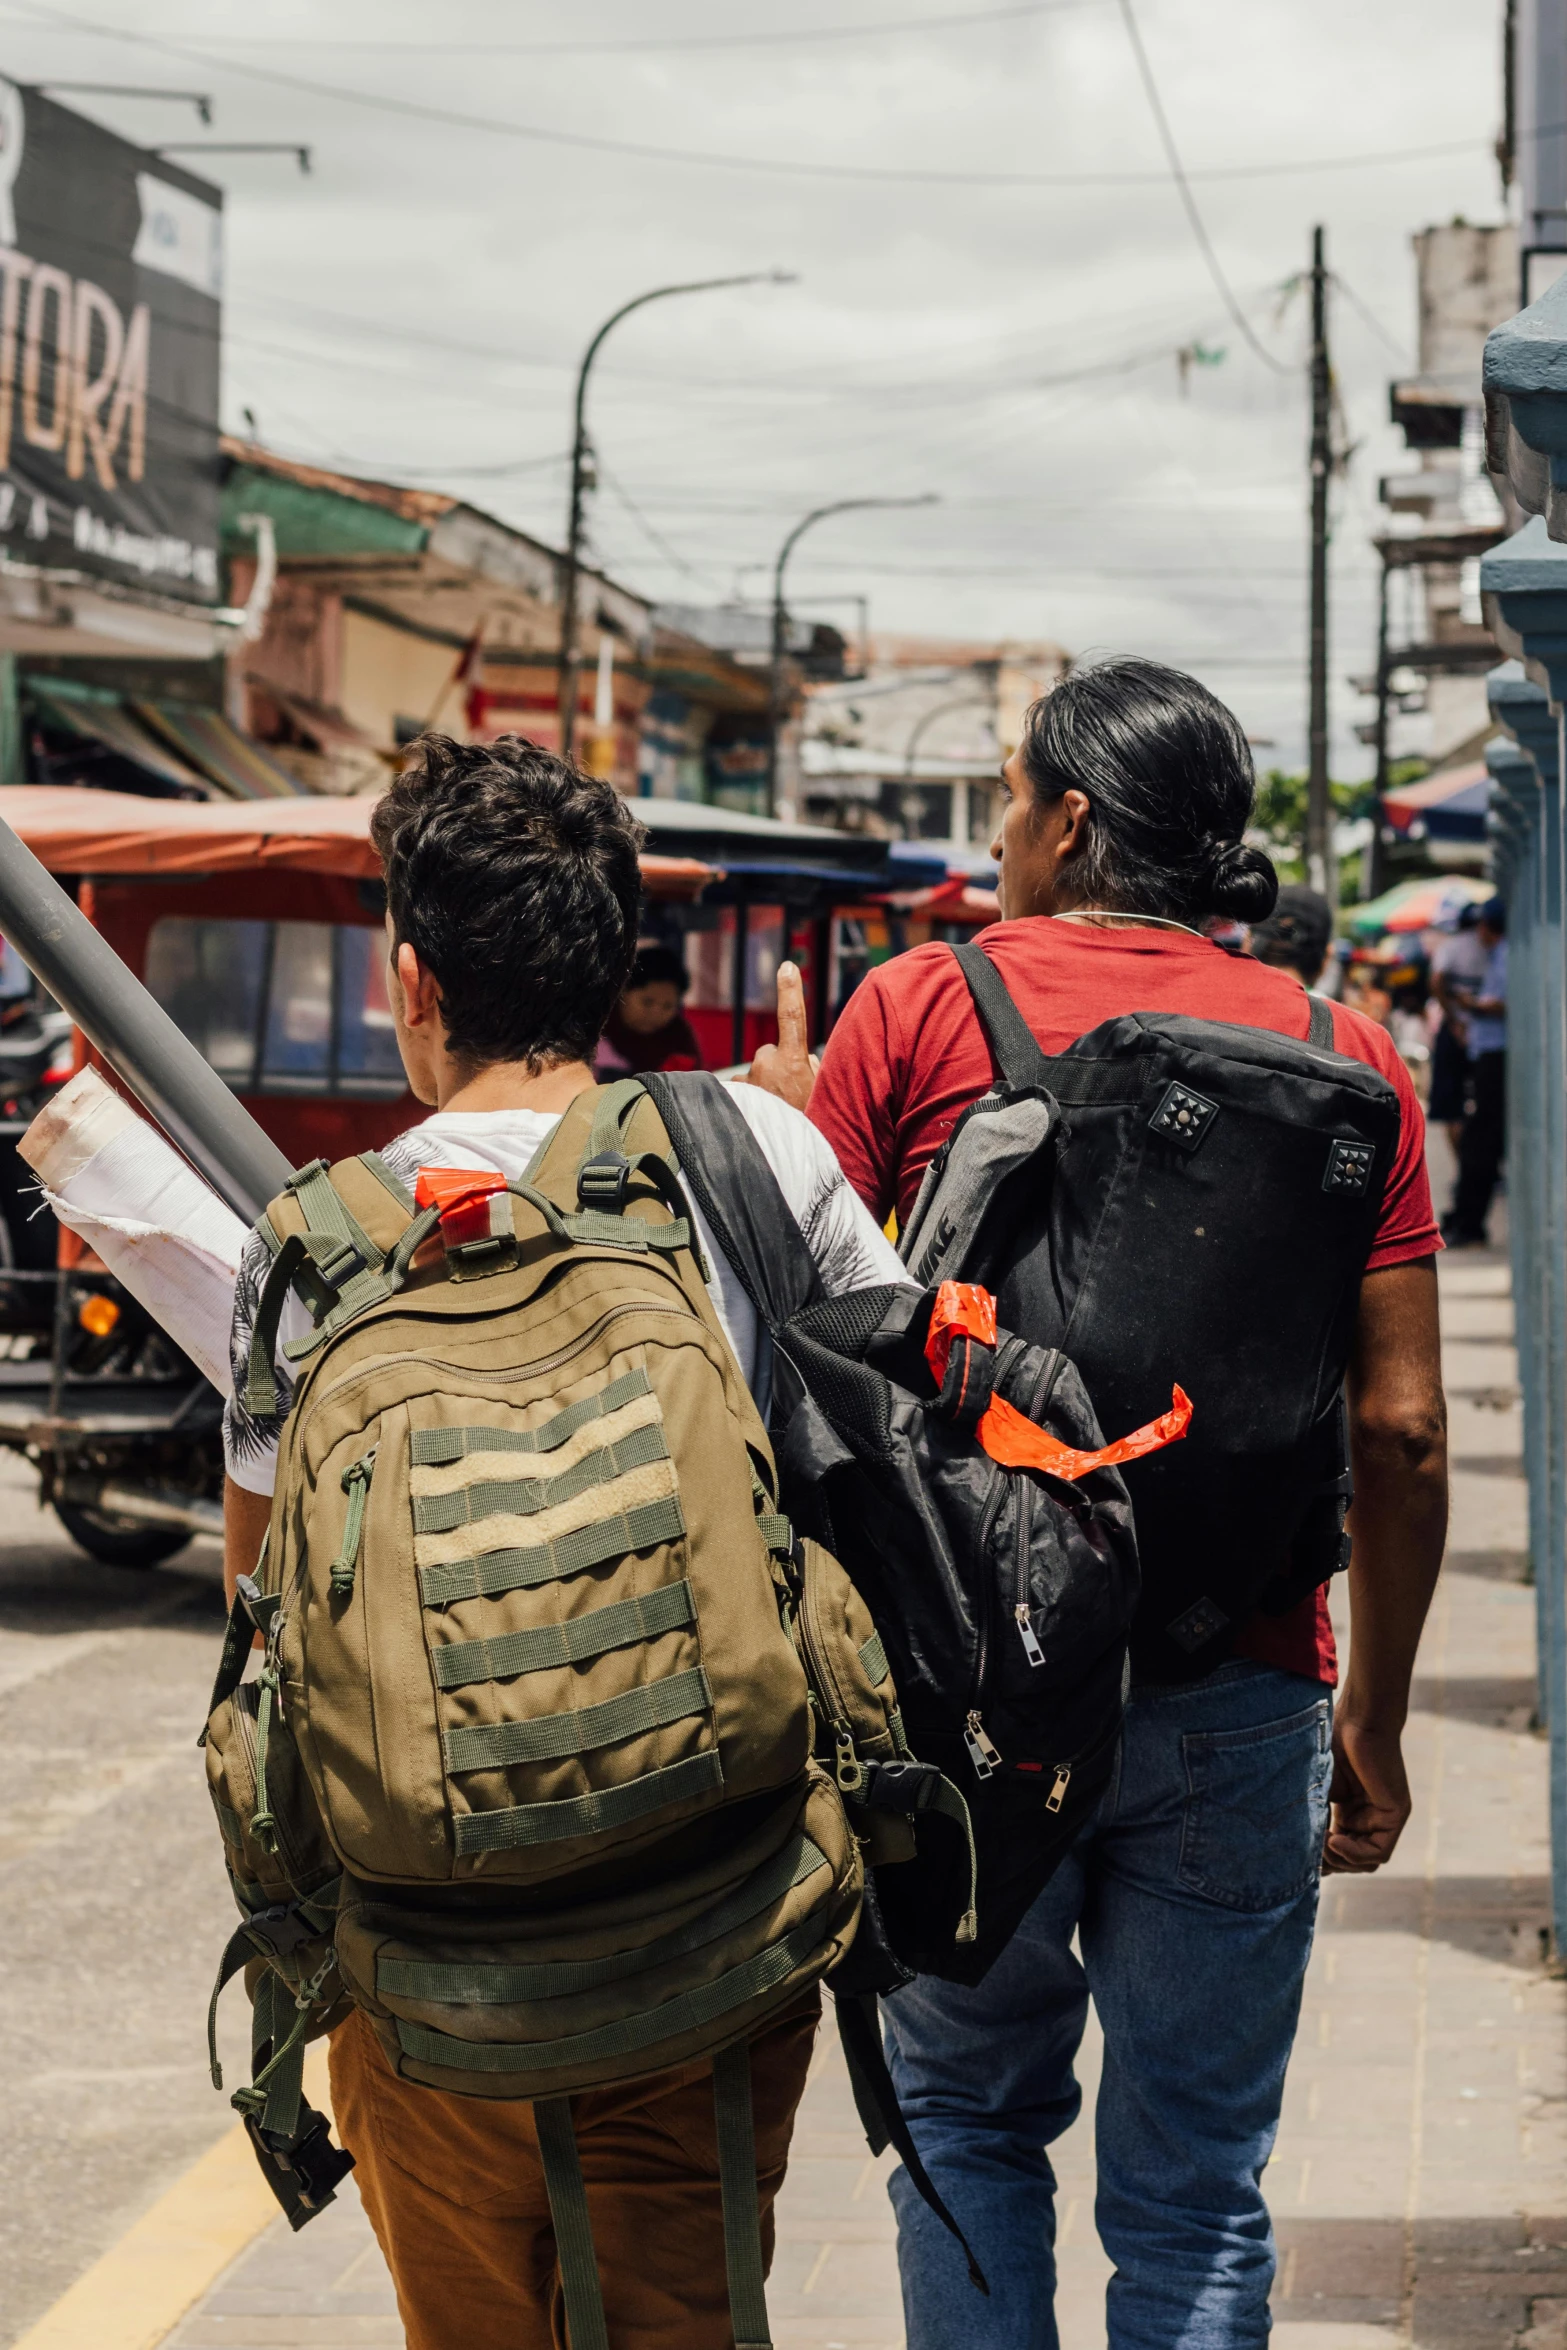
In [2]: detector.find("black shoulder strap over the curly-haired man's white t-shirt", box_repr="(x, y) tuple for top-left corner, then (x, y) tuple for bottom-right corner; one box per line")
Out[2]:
(641, 1069), (825, 1330)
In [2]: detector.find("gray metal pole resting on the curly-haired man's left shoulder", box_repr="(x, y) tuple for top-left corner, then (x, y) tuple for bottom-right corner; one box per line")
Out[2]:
(0, 818), (291, 1224)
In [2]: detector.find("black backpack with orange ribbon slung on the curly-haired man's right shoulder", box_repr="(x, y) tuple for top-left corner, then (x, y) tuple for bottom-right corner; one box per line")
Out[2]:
(644, 1074), (1151, 1990)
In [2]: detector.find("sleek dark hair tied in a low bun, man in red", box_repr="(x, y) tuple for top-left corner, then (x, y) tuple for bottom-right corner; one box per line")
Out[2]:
(1020, 660), (1278, 924)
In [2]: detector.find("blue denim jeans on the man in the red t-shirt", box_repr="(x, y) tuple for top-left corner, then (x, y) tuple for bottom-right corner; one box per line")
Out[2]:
(883, 1664), (1332, 2350)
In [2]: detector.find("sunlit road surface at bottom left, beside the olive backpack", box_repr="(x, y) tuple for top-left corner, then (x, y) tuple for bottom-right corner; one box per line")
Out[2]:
(0, 1455), (244, 2343)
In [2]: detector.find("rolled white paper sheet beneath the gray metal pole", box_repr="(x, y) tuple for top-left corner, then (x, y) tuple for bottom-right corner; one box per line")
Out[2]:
(16, 1069), (244, 1396)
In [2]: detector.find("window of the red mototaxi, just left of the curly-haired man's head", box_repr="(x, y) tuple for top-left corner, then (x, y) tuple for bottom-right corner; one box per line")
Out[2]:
(146, 917), (406, 1100)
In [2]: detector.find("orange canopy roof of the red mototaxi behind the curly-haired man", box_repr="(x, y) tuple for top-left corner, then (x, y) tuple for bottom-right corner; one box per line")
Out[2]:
(0, 783), (719, 898)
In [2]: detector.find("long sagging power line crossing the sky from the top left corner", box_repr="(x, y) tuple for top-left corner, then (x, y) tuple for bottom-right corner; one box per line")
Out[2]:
(6, 0), (1487, 196)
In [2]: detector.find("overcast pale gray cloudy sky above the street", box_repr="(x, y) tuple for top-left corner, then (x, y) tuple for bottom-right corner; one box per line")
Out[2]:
(0, 0), (1501, 776)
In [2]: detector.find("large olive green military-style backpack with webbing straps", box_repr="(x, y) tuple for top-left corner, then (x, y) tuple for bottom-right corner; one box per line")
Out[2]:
(204, 1081), (972, 2350)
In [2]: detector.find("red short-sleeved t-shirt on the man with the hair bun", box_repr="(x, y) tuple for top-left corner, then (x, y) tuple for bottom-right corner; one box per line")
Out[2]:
(811, 917), (1442, 1683)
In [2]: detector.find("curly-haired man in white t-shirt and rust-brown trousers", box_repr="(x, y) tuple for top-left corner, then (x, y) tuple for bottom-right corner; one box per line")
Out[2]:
(223, 736), (904, 2350)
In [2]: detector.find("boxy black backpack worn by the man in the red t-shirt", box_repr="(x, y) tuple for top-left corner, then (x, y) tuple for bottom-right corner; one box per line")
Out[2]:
(902, 945), (1400, 1683)
